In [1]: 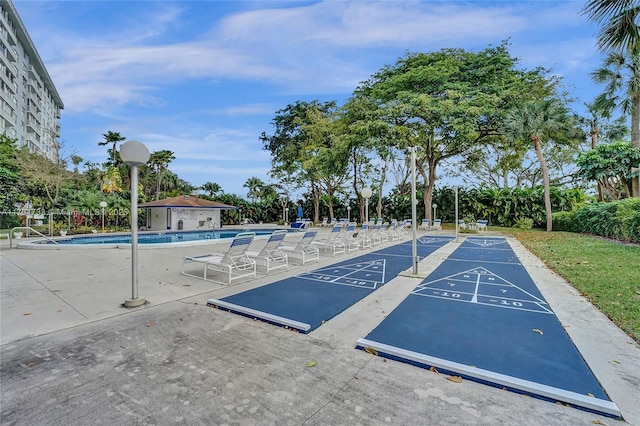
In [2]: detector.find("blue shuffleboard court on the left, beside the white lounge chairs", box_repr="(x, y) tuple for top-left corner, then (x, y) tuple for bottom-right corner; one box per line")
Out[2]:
(207, 237), (452, 333)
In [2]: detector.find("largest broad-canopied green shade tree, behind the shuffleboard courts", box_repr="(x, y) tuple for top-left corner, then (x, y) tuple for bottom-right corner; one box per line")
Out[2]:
(356, 43), (548, 223)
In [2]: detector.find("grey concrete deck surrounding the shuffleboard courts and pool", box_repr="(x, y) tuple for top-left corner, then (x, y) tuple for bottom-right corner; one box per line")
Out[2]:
(0, 231), (640, 426)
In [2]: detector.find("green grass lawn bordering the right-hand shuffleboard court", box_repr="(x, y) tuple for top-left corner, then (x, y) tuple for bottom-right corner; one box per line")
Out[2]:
(496, 228), (640, 342)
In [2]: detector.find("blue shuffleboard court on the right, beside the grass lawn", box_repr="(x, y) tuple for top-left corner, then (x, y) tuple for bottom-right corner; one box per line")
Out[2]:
(357, 238), (621, 418)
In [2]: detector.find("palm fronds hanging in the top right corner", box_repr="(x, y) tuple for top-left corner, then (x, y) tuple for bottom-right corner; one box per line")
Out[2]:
(582, 0), (640, 53)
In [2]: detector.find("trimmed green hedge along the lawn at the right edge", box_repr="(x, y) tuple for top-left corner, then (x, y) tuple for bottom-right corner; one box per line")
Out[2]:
(553, 198), (640, 243)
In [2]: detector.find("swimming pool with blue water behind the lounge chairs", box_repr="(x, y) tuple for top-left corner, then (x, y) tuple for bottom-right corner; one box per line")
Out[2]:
(17, 228), (300, 249)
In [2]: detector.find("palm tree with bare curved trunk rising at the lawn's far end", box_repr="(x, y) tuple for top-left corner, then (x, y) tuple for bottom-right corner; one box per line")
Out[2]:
(505, 98), (571, 232)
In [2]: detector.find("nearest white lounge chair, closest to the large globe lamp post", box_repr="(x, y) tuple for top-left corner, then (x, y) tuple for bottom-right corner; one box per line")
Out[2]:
(181, 232), (256, 285)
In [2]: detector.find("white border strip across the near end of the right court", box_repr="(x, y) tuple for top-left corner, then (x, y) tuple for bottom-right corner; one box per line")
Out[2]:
(356, 338), (622, 420)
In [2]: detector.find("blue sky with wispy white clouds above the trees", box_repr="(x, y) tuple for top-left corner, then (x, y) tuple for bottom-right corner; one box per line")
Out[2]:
(14, 0), (602, 197)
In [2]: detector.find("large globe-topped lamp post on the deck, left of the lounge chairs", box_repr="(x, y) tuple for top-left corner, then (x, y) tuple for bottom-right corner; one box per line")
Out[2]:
(120, 141), (149, 308)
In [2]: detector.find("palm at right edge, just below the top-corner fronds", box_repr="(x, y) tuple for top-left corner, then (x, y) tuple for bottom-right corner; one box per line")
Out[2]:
(591, 49), (640, 197)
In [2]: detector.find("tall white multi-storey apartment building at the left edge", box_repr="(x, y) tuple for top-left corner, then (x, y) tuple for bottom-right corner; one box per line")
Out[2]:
(0, 0), (64, 161)
